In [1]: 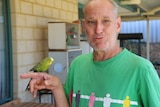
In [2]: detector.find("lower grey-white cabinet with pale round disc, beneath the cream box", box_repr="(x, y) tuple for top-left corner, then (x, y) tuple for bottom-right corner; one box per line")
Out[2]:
(48, 49), (82, 83)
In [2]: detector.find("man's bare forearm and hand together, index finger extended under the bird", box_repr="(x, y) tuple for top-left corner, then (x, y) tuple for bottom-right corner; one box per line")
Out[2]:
(20, 73), (69, 107)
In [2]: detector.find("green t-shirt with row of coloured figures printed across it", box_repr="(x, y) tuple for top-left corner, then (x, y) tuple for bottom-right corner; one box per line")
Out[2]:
(64, 49), (160, 107)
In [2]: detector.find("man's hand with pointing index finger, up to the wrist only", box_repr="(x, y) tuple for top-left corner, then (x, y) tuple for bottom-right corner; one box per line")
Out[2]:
(20, 73), (62, 97)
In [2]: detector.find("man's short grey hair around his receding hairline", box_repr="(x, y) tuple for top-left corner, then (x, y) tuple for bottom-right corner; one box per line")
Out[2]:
(83, 0), (118, 15)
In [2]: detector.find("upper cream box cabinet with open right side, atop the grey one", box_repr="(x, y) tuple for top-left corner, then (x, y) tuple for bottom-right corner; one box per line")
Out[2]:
(48, 22), (80, 50)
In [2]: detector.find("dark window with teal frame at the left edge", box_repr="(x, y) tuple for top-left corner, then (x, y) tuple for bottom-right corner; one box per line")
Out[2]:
(0, 0), (13, 104)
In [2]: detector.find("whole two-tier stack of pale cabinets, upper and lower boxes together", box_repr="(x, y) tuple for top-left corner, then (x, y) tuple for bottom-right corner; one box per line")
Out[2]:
(48, 22), (82, 83)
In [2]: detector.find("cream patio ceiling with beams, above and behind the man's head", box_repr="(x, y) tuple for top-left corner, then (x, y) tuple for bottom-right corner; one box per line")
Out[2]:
(78, 0), (160, 20)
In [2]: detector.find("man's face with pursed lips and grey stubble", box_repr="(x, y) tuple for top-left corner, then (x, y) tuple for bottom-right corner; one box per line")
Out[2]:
(83, 2), (121, 51)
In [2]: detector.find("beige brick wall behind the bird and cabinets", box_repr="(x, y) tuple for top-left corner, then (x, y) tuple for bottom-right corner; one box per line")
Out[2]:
(10, 0), (78, 101)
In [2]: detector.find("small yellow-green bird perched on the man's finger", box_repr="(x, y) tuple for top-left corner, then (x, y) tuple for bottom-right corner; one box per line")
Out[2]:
(26, 57), (54, 90)
